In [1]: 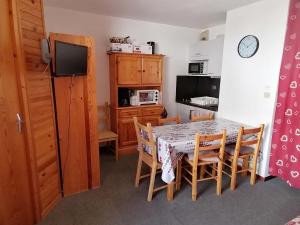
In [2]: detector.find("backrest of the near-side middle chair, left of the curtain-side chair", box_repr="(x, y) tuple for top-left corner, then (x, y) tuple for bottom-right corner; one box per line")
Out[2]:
(194, 130), (226, 166)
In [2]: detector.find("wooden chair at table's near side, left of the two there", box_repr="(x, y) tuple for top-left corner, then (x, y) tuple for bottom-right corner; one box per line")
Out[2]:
(176, 130), (226, 201)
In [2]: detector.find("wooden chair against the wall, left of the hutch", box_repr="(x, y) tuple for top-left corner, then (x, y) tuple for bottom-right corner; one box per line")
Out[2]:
(97, 102), (119, 160)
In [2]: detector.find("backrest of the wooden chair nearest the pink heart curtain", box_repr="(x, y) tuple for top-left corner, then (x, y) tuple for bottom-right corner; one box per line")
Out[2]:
(234, 124), (264, 155)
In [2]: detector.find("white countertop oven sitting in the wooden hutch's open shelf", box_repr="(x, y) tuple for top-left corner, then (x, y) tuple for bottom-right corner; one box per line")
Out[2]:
(130, 89), (160, 106)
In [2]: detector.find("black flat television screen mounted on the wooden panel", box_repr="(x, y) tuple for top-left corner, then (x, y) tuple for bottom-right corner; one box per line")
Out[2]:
(55, 41), (88, 76)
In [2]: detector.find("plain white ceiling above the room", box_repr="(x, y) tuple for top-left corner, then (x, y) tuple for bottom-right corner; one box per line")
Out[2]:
(44, 0), (260, 28)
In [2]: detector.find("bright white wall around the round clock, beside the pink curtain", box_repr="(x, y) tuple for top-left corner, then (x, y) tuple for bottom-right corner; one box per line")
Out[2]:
(219, 0), (289, 177)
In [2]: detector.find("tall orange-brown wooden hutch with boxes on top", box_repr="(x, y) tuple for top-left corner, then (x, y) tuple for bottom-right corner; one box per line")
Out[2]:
(108, 53), (164, 154)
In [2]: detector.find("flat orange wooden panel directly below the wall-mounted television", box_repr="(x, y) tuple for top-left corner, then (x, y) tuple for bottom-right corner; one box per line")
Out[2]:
(54, 76), (88, 196)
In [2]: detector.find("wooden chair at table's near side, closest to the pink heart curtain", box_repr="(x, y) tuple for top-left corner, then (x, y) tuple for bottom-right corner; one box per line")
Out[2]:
(223, 124), (264, 190)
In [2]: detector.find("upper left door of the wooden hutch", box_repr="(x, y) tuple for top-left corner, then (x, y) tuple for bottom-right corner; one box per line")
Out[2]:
(117, 56), (142, 85)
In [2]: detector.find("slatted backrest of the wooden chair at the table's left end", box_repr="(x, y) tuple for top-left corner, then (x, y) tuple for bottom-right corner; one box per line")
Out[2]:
(133, 117), (157, 162)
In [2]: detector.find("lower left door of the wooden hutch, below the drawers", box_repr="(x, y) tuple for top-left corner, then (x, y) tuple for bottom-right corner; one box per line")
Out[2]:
(118, 118), (137, 146)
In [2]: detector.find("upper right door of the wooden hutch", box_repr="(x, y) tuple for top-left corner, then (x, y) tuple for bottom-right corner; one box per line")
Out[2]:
(142, 57), (162, 85)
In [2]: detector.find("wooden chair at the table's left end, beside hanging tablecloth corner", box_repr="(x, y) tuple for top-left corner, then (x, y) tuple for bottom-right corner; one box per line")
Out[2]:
(133, 117), (168, 202)
